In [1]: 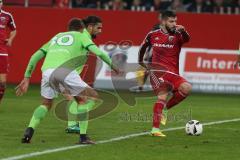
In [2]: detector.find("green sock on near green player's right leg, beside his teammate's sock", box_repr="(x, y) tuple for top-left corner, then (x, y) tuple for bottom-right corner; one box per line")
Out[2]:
(78, 100), (95, 134)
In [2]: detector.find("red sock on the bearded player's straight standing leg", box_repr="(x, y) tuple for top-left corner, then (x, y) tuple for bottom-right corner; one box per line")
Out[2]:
(153, 100), (166, 128)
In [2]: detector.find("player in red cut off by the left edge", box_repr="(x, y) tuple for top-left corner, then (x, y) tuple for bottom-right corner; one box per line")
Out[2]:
(0, 0), (16, 102)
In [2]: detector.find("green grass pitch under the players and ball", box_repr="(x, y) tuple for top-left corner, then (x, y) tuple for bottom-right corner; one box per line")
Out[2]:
(0, 86), (240, 160)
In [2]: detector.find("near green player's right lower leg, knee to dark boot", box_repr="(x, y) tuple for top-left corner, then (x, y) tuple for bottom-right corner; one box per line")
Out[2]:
(75, 87), (98, 144)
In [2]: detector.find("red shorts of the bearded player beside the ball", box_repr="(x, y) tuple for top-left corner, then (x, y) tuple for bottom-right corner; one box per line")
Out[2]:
(150, 72), (187, 95)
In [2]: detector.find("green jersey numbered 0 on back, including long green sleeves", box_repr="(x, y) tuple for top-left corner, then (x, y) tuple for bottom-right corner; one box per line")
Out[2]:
(24, 29), (113, 77)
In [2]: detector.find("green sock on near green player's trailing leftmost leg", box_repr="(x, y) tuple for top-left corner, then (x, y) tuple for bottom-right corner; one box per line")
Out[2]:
(28, 105), (48, 129)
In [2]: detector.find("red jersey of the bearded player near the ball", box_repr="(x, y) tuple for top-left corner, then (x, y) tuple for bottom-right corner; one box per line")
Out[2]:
(139, 29), (190, 74)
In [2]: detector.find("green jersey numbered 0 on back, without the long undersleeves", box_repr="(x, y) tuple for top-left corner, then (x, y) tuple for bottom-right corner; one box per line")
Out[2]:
(41, 31), (95, 72)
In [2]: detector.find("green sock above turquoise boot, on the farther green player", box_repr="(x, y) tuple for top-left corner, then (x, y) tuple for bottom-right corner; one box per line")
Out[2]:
(68, 100), (78, 127)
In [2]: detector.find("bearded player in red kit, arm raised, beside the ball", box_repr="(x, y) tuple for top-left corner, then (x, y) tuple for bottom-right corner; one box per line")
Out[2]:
(139, 11), (192, 137)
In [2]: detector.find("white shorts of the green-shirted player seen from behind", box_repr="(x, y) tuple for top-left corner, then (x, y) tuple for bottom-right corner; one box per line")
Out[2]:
(41, 68), (89, 99)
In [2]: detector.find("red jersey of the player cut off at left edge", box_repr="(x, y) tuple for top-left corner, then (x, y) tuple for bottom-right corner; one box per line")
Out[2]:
(0, 10), (16, 54)
